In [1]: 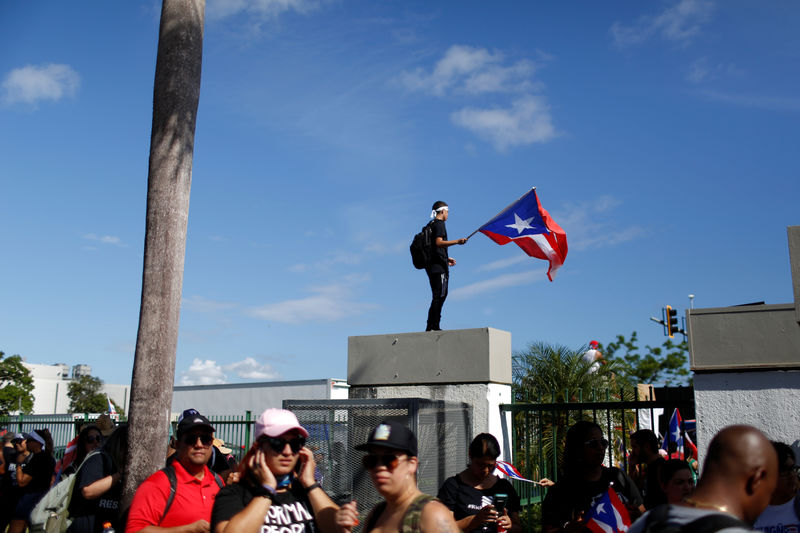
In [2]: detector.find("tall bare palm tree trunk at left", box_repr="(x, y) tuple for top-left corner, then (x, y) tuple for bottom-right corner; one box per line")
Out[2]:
(122, 0), (205, 509)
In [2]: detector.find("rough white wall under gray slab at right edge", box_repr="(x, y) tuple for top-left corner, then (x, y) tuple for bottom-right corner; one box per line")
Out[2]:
(694, 370), (800, 464)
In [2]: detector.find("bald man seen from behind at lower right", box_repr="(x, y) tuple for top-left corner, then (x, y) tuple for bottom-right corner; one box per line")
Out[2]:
(629, 426), (778, 533)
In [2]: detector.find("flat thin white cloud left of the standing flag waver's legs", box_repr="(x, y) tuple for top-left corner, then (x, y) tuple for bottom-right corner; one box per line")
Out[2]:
(248, 277), (378, 324)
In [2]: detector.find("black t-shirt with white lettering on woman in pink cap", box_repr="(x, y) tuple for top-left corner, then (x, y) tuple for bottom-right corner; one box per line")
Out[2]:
(211, 481), (318, 533)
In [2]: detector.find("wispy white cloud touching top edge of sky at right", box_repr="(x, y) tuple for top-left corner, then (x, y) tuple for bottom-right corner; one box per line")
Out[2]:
(610, 0), (714, 47)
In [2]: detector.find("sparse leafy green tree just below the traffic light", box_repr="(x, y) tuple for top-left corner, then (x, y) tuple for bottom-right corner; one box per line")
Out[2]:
(600, 331), (690, 385)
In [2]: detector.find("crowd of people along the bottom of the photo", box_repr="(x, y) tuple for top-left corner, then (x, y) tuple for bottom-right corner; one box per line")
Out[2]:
(0, 409), (800, 533)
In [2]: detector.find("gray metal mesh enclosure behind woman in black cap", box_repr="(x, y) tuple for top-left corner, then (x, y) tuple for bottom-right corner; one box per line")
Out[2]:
(283, 398), (472, 524)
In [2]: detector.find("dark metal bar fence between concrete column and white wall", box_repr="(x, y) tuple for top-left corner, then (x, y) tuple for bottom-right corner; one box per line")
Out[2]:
(500, 389), (694, 531)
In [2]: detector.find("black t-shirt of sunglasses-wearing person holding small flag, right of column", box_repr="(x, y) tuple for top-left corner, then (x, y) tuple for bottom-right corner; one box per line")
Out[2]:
(542, 467), (642, 527)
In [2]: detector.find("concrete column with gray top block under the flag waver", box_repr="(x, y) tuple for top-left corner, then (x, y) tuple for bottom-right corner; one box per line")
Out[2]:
(347, 328), (512, 461)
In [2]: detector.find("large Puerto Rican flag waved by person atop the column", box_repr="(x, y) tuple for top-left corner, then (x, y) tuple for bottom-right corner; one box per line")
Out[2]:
(478, 187), (567, 281)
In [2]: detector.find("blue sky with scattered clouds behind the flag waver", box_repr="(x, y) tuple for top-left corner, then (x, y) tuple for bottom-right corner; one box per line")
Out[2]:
(0, 0), (800, 384)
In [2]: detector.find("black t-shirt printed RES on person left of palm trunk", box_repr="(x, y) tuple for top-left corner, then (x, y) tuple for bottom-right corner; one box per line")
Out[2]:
(69, 451), (124, 533)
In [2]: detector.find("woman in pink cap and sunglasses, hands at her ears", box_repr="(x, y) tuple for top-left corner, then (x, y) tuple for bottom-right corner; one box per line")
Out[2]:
(211, 409), (338, 533)
